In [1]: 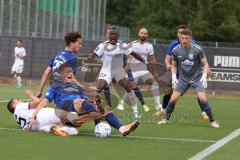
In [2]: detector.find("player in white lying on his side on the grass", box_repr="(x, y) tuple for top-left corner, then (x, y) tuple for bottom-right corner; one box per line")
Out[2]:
(7, 90), (78, 136)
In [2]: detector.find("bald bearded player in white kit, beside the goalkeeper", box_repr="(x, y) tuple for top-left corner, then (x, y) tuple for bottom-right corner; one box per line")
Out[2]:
(118, 28), (162, 114)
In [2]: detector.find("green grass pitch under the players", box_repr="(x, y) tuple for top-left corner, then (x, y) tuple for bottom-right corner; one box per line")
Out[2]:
(0, 84), (240, 160)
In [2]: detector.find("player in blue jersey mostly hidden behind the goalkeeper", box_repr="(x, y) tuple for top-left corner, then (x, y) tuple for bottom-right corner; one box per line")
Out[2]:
(155, 25), (211, 120)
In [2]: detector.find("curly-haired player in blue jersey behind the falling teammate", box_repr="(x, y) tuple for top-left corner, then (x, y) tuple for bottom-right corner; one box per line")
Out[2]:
(37, 32), (82, 97)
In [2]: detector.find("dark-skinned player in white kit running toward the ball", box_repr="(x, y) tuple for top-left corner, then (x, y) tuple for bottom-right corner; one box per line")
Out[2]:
(89, 28), (144, 118)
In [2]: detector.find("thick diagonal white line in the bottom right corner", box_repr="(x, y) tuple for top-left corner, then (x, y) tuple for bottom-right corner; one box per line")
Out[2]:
(188, 128), (240, 160)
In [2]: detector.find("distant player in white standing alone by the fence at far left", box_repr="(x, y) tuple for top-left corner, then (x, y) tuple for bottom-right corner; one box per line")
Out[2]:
(11, 39), (26, 88)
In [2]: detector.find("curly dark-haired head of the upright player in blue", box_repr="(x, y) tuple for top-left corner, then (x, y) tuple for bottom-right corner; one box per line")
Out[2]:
(64, 32), (82, 52)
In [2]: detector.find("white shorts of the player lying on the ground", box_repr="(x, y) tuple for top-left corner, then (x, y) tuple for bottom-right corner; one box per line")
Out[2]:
(32, 108), (61, 131)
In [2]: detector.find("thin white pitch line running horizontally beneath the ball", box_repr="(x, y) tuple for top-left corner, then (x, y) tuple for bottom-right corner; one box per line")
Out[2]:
(0, 128), (216, 143)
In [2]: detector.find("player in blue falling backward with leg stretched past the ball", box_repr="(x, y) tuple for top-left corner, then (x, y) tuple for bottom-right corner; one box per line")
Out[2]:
(29, 64), (139, 136)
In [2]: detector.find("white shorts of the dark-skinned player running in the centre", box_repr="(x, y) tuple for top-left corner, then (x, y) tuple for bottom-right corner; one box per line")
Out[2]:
(98, 68), (126, 84)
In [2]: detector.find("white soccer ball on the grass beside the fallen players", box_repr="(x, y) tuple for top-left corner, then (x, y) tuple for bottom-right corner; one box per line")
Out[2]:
(95, 122), (111, 138)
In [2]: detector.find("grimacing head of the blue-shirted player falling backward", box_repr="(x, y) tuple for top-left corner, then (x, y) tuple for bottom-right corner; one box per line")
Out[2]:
(59, 64), (73, 83)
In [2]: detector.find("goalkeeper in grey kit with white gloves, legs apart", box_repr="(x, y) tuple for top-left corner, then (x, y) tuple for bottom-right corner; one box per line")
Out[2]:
(158, 28), (220, 128)
